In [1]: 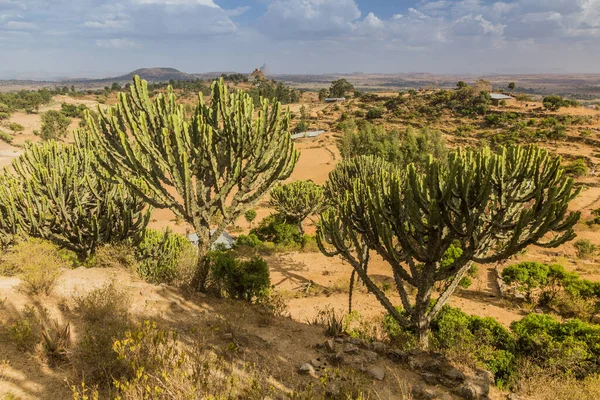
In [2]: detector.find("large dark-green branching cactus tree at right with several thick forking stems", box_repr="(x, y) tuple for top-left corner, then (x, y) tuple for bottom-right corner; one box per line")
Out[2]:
(318, 146), (580, 347)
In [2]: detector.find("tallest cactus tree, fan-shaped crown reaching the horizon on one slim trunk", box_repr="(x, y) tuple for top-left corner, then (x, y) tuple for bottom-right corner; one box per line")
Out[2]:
(84, 76), (298, 290)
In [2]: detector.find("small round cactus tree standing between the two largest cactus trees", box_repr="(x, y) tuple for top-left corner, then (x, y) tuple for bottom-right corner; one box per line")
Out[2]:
(270, 181), (324, 234)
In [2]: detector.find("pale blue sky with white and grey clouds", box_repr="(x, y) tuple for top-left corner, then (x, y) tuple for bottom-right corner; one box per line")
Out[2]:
(0, 0), (600, 78)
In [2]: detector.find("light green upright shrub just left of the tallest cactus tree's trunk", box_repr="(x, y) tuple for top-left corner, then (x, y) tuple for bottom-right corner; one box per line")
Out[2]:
(136, 229), (193, 283)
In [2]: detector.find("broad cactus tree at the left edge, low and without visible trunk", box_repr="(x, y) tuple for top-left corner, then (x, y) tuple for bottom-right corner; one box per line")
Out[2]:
(0, 141), (150, 260)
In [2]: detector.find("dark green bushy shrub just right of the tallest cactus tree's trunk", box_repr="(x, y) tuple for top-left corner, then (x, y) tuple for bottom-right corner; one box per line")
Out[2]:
(208, 251), (271, 301)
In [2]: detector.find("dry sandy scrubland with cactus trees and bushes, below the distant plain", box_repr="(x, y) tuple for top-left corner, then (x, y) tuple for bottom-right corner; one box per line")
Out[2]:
(0, 74), (600, 400)
